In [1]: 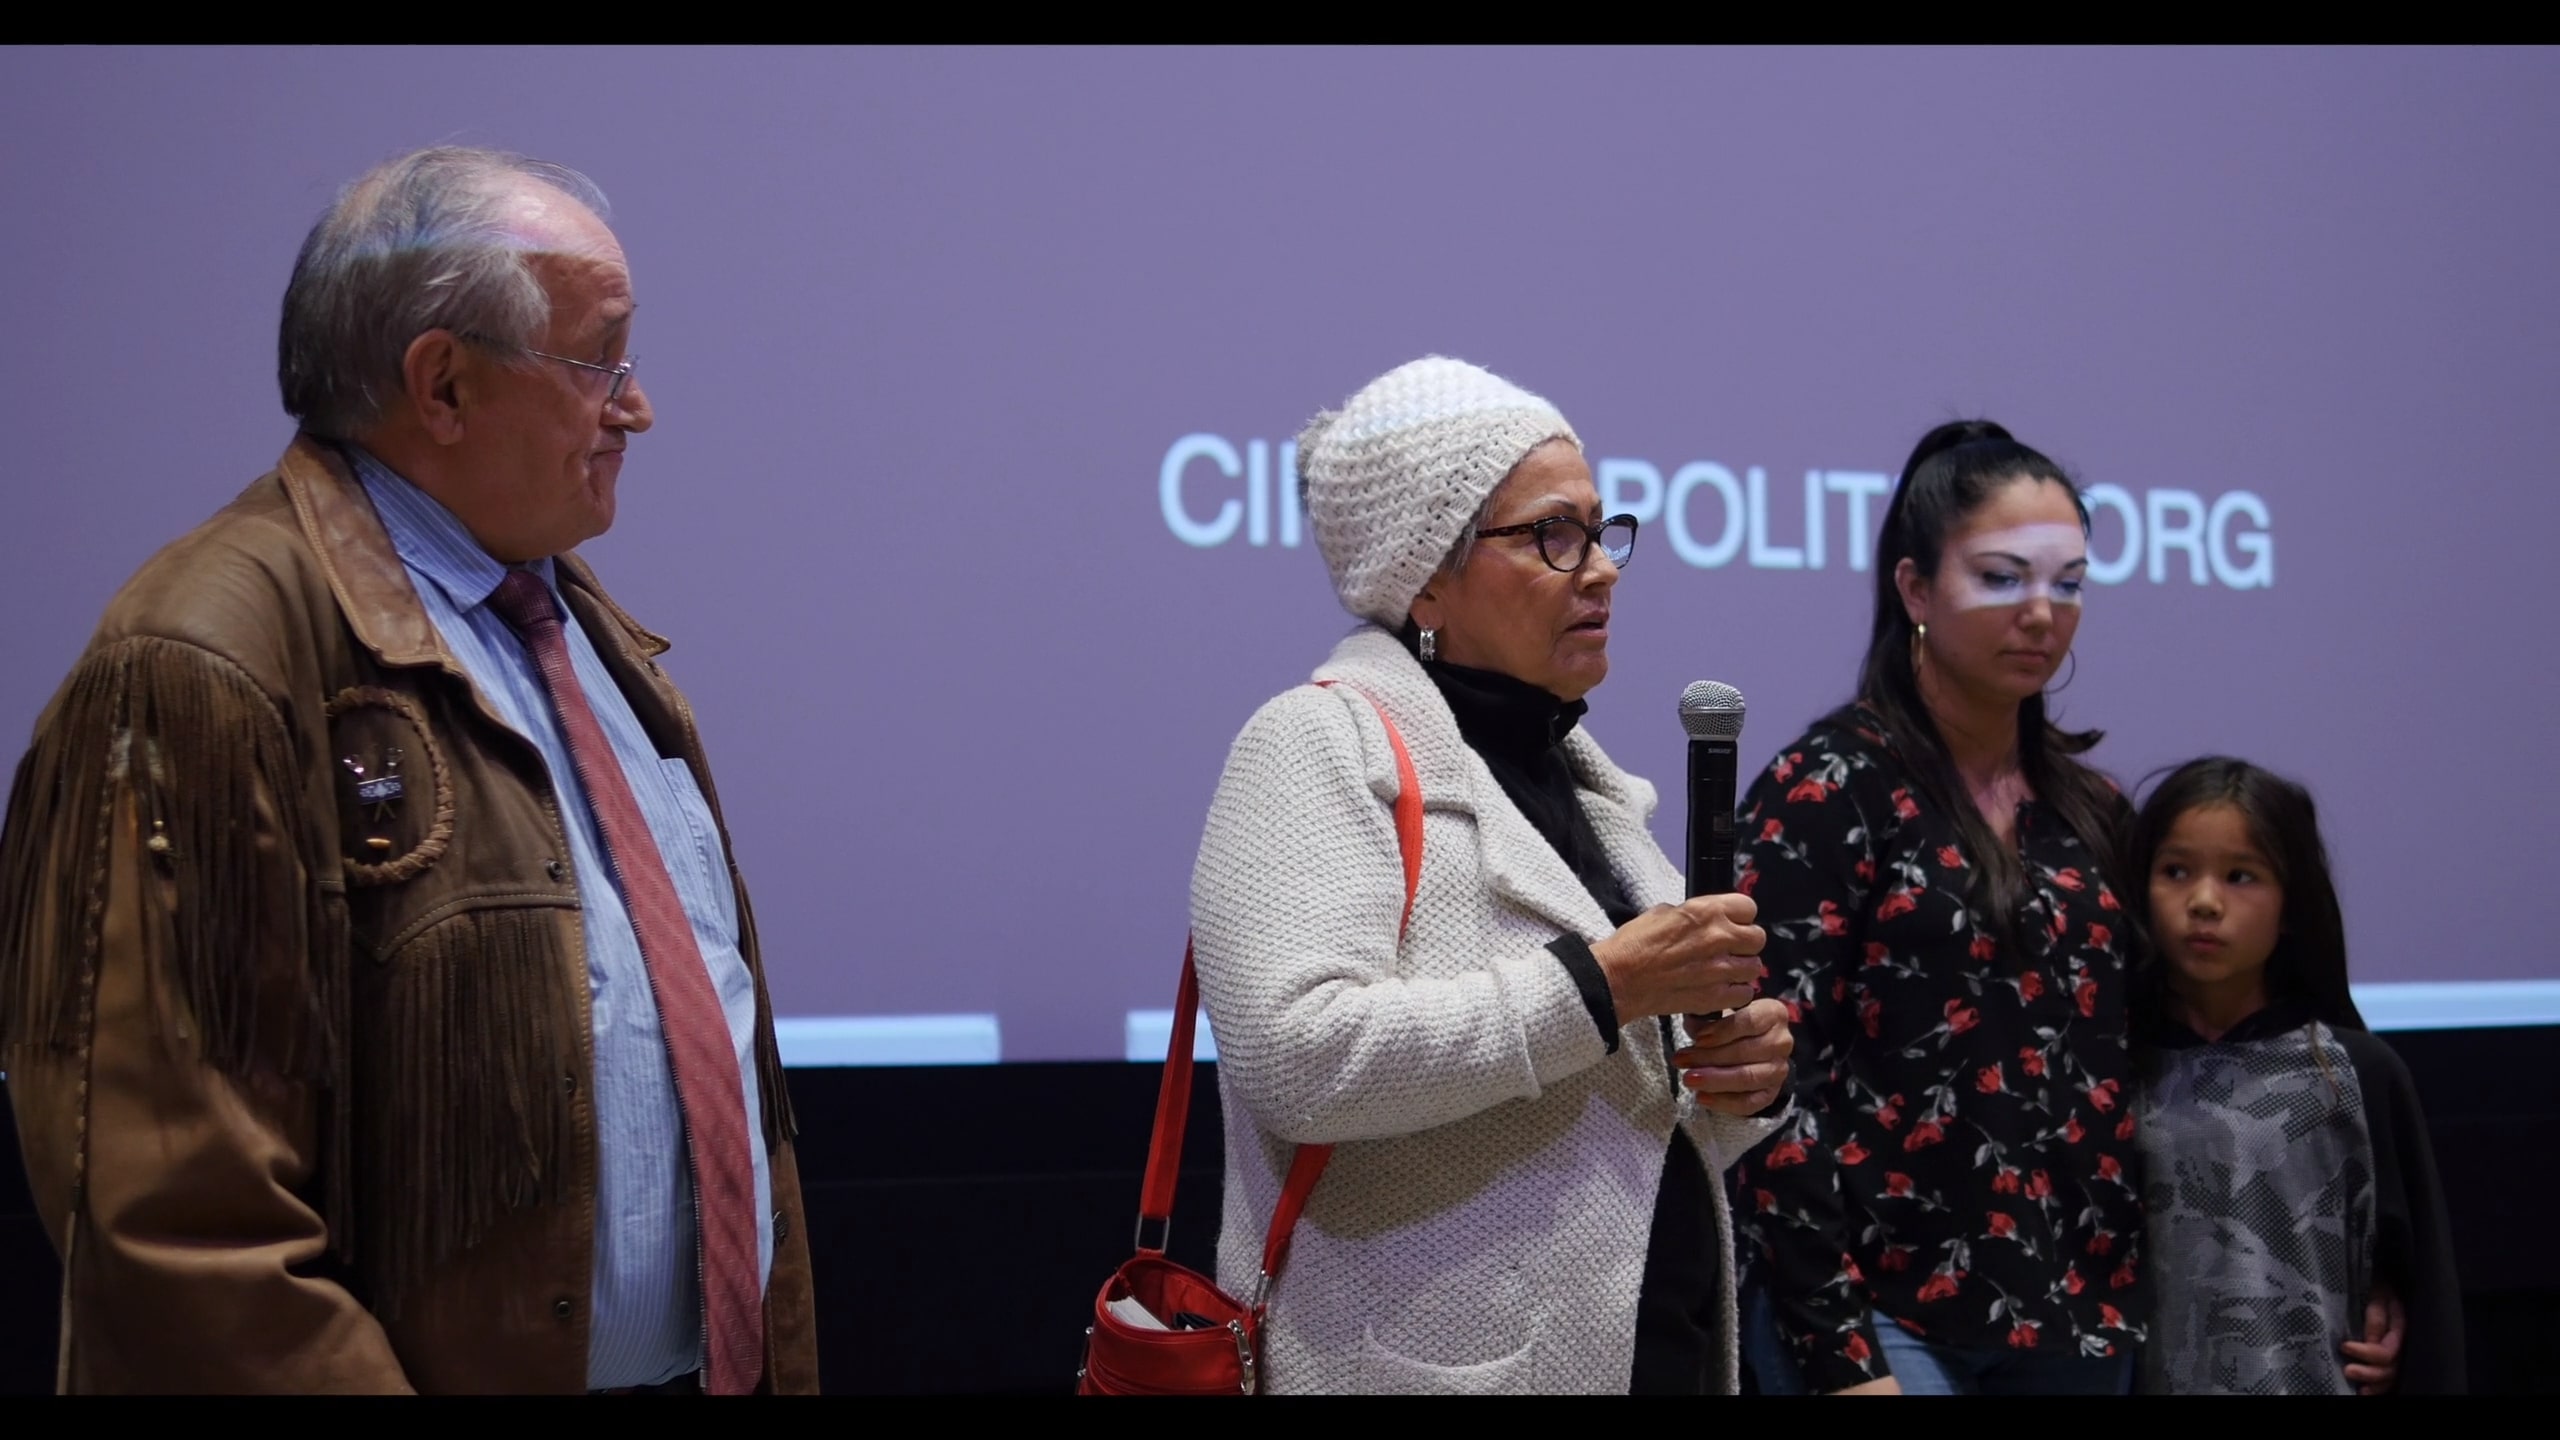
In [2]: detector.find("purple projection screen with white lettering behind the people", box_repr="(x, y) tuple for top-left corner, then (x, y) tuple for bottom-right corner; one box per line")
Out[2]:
(0, 49), (2560, 1063)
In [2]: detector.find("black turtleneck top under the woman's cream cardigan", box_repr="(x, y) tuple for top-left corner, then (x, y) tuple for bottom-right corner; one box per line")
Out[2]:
(1405, 638), (1723, 1394)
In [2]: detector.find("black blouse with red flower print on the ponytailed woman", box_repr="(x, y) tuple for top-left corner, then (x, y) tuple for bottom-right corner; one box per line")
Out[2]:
(1736, 710), (2143, 1391)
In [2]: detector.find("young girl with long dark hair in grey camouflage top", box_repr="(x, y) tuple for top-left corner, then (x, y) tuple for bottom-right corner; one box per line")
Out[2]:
(2125, 756), (2463, 1394)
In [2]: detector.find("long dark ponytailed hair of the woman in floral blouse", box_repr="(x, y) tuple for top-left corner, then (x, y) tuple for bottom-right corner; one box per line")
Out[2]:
(1833, 420), (2125, 963)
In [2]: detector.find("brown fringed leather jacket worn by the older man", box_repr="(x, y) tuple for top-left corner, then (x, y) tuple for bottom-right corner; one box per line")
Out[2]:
(0, 438), (817, 1391)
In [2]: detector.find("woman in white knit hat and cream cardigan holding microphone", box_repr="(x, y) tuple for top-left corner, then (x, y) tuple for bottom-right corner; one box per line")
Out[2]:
(1193, 356), (1789, 1394)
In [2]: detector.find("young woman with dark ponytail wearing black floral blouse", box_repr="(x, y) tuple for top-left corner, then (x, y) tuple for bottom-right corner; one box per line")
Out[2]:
(1738, 420), (2143, 1394)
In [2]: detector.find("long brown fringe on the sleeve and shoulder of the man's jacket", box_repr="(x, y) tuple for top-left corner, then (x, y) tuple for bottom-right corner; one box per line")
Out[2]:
(0, 635), (346, 1086)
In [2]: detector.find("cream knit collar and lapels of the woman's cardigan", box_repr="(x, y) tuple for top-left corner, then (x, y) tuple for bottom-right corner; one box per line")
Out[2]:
(1313, 625), (1679, 940)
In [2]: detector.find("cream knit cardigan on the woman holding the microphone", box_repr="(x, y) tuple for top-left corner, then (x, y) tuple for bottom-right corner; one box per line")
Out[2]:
(1190, 625), (1777, 1394)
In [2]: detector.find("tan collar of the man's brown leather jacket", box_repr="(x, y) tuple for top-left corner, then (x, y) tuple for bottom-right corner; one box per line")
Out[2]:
(276, 436), (666, 674)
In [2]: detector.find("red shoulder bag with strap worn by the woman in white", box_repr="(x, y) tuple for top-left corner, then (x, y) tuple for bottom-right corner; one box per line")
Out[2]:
(1075, 682), (1423, 1394)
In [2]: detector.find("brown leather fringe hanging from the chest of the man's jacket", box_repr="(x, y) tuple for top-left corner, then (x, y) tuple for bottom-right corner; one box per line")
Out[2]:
(353, 907), (586, 1317)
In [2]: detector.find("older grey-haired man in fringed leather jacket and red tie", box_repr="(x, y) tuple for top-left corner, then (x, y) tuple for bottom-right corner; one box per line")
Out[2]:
(0, 149), (817, 1394)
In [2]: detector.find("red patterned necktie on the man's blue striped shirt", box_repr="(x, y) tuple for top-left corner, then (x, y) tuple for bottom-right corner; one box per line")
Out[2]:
(489, 569), (765, 1394)
